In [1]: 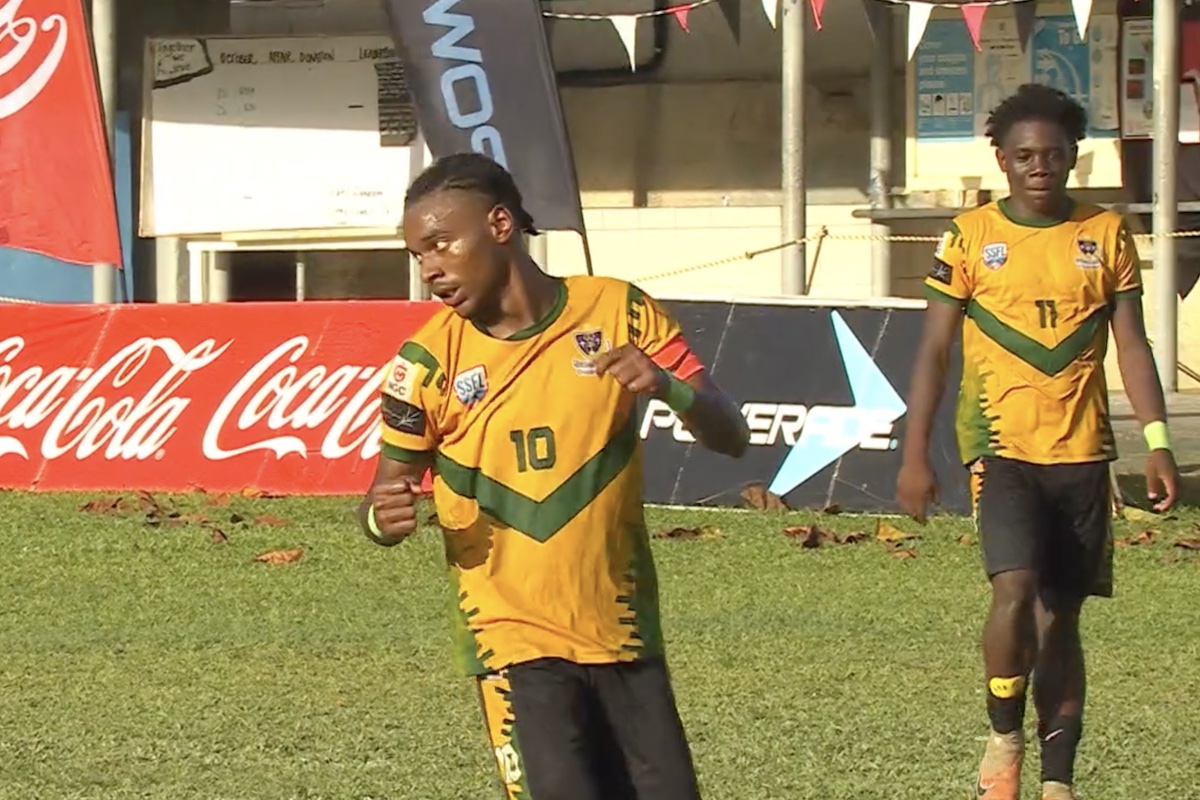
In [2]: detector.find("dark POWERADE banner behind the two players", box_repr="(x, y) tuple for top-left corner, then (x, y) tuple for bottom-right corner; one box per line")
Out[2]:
(641, 301), (970, 512)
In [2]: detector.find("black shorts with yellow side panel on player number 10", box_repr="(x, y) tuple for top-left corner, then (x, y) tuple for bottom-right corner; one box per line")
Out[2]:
(479, 658), (700, 800)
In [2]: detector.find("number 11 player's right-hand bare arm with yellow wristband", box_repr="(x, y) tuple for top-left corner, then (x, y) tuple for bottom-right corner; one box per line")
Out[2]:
(1112, 296), (1180, 511)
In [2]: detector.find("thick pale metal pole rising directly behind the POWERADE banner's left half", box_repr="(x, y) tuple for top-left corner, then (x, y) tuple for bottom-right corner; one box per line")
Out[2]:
(780, 0), (809, 295)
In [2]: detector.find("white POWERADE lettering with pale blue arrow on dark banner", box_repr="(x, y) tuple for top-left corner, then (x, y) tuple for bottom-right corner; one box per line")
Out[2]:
(641, 312), (907, 497)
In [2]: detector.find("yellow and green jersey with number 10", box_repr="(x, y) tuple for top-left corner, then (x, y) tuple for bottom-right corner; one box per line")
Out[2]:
(383, 277), (701, 675)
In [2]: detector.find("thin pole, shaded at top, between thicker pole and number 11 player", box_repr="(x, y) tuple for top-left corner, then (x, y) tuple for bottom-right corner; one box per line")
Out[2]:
(868, 0), (892, 297)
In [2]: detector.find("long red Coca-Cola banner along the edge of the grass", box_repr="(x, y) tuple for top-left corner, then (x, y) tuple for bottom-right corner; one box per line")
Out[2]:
(0, 302), (439, 494)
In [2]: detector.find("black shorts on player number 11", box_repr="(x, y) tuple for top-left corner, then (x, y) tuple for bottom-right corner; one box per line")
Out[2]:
(970, 457), (1112, 602)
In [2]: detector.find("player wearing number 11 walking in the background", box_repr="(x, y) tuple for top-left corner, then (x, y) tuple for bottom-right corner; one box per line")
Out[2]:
(896, 84), (1178, 800)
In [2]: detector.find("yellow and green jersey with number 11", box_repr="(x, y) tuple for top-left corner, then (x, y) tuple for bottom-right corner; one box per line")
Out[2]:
(925, 200), (1141, 464)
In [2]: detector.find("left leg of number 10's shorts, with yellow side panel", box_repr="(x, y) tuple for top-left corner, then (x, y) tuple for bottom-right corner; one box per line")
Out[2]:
(479, 658), (604, 800)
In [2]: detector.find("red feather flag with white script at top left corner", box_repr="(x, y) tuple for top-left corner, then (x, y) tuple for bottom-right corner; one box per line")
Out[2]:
(0, 0), (121, 266)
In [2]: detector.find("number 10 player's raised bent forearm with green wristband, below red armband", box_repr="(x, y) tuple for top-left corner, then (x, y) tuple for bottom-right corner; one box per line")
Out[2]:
(595, 344), (750, 458)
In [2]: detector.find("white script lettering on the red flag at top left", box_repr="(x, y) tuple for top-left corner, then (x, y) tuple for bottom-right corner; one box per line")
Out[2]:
(0, 0), (70, 120)
